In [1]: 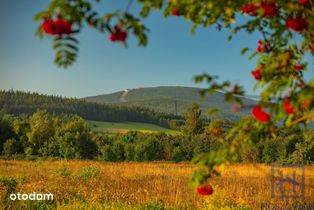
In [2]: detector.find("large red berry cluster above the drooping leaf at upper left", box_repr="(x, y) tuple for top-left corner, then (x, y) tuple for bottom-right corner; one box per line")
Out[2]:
(41, 17), (72, 36)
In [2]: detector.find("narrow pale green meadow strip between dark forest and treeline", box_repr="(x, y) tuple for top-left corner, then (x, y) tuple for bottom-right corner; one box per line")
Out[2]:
(87, 121), (178, 134)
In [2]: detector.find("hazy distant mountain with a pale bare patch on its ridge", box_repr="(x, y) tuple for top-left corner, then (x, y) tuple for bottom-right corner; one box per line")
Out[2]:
(85, 87), (256, 120)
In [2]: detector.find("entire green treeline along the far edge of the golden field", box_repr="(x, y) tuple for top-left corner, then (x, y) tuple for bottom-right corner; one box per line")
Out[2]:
(0, 110), (314, 164)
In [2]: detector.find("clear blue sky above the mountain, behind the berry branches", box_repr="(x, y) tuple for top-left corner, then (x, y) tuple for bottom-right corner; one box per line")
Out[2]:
(0, 0), (312, 97)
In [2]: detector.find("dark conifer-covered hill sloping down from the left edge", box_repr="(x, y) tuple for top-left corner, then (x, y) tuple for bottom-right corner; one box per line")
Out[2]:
(0, 90), (181, 127)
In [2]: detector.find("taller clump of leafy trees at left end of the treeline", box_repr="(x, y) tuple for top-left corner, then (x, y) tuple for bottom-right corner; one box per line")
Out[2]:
(0, 110), (96, 159)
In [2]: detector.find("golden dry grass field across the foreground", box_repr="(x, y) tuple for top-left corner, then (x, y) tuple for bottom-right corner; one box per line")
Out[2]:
(0, 161), (314, 210)
